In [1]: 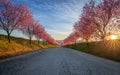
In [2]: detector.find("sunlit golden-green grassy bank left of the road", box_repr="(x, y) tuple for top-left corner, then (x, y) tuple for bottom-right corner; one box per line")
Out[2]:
(0, 35), (55, 59)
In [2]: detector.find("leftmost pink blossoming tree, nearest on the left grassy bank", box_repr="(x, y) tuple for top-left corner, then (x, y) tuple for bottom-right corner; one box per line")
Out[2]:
(0, 0), (32, 43)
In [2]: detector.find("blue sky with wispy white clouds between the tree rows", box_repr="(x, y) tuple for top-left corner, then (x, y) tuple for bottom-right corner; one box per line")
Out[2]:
(0, 0), (89, 40)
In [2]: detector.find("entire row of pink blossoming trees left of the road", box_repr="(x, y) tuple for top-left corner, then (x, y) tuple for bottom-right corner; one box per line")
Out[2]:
(0, 0), (58, 44)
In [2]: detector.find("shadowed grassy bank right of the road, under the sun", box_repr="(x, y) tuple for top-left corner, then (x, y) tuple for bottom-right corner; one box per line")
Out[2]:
(65, 40), (120, 62)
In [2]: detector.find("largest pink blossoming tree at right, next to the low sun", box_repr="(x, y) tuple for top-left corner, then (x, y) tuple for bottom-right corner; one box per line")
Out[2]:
(88, 0), (120, 39)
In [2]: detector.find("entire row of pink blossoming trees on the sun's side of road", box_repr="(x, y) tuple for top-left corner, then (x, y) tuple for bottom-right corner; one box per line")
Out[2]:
(63, 0), (120, 43)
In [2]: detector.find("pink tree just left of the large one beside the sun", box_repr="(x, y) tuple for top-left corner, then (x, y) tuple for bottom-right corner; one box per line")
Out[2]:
(74, 1), (96, 45)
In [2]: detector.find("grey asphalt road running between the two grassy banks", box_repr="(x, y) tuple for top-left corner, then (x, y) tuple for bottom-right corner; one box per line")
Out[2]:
(0, 47), (120, 75)
